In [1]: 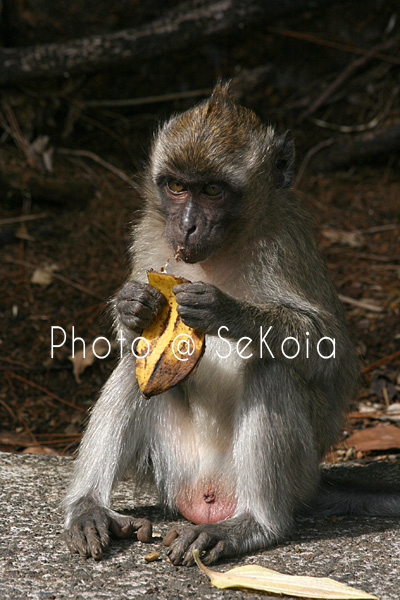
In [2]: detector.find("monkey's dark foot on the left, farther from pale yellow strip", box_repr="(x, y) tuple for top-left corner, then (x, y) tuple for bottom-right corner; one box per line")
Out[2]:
(65, 505), (152, 560)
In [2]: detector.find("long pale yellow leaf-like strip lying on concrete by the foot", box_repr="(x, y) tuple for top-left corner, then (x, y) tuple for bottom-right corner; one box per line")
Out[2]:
(193, 550), (378, 600)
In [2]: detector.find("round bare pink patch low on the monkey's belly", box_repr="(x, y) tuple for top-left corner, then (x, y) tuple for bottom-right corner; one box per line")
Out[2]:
(176, 481), (237, 524)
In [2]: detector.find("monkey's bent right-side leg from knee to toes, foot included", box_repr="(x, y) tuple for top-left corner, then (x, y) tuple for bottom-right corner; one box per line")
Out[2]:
(165, 360), (324, 566)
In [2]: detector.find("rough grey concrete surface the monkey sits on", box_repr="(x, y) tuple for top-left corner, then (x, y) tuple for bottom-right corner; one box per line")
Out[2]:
(0, 453), (400, 600)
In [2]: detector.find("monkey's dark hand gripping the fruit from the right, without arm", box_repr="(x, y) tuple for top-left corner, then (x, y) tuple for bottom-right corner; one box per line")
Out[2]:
(172, 282), (237, 335)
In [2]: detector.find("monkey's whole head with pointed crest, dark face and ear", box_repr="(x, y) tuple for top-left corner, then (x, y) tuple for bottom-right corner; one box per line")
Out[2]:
(148, 83), (294, 263)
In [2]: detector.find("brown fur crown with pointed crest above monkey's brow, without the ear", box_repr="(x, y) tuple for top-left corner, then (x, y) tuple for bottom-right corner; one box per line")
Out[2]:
(151, 83), (272, 187)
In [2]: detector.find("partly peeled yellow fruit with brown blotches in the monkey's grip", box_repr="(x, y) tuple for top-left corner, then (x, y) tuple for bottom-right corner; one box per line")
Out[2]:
(135, 271), (205, 398)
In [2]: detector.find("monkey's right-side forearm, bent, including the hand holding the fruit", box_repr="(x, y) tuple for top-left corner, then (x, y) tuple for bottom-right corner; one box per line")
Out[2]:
(174, 283), (354, 387)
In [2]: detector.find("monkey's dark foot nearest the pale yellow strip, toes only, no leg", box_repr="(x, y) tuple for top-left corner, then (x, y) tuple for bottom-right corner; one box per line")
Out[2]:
(163, 523), (236, 567)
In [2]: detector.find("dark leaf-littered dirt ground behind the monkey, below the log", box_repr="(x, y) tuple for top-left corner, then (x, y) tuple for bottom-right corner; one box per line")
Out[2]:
(0, 3), (400, 461)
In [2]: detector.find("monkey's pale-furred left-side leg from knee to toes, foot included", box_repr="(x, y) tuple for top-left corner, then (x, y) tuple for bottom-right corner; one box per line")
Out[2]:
(64, 355), (151, 559)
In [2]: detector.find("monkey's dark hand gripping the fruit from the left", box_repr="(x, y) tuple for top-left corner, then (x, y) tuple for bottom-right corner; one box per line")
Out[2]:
(115, 281), (167, 332)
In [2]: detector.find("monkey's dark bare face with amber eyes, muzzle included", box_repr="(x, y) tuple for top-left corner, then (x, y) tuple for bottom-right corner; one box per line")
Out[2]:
(159, 177), (237, 263)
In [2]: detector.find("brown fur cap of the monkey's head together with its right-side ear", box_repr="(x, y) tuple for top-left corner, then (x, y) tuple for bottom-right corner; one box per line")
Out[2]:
(150, 81), (294, 191)
